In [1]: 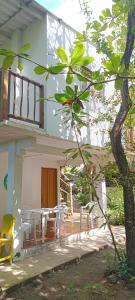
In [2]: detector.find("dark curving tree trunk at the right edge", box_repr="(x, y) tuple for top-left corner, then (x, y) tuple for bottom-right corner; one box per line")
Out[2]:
(110, 1), (135, 274)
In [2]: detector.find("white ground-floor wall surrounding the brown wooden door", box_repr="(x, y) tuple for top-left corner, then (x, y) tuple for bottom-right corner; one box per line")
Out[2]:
(22, 155), (60, 208)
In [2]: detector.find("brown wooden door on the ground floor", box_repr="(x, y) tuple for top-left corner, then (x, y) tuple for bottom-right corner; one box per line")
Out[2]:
(41, 168), (57, 208)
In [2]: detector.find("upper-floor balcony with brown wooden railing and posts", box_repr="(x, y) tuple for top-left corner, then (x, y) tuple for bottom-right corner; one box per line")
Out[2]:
(0, 69), (44, 128)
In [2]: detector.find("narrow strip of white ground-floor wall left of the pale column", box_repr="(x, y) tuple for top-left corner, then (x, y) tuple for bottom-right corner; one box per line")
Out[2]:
(0, 152), (8, 218)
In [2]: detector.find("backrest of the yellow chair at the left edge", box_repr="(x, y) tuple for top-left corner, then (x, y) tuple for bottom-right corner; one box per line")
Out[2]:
(1, 214), (15, 238)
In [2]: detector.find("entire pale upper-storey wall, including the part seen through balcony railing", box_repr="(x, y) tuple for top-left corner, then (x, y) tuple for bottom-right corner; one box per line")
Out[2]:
(0, 6), (107, 146)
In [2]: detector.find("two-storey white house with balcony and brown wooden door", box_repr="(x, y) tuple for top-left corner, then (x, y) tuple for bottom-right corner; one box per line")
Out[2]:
(0, 0), (107, 253)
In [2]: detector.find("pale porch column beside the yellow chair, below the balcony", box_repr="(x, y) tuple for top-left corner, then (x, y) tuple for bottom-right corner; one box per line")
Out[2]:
(7, 143), (22, 255)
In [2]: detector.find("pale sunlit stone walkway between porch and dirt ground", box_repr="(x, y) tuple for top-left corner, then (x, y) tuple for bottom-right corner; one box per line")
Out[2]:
(0, 226), (125, 291)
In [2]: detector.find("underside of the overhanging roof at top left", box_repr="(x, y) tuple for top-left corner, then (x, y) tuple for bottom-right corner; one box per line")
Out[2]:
(0, 0), (46, 47)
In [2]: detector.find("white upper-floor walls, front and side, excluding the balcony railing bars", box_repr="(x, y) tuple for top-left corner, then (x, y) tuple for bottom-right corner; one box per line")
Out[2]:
(0, 14), (106, 146)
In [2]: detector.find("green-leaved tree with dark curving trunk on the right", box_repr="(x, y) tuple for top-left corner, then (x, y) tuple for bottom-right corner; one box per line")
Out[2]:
(0, 0), (135, 273)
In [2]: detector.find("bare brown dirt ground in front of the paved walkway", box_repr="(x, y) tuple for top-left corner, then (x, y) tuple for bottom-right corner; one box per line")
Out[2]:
(4, 249), (135, 300)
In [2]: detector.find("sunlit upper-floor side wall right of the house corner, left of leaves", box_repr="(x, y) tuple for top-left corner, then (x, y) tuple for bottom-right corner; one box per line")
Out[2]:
(46, 15), (75, 139)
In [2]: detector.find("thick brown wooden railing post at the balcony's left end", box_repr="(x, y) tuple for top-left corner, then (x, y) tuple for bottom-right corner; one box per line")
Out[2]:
(0, 70), (9, 121)
